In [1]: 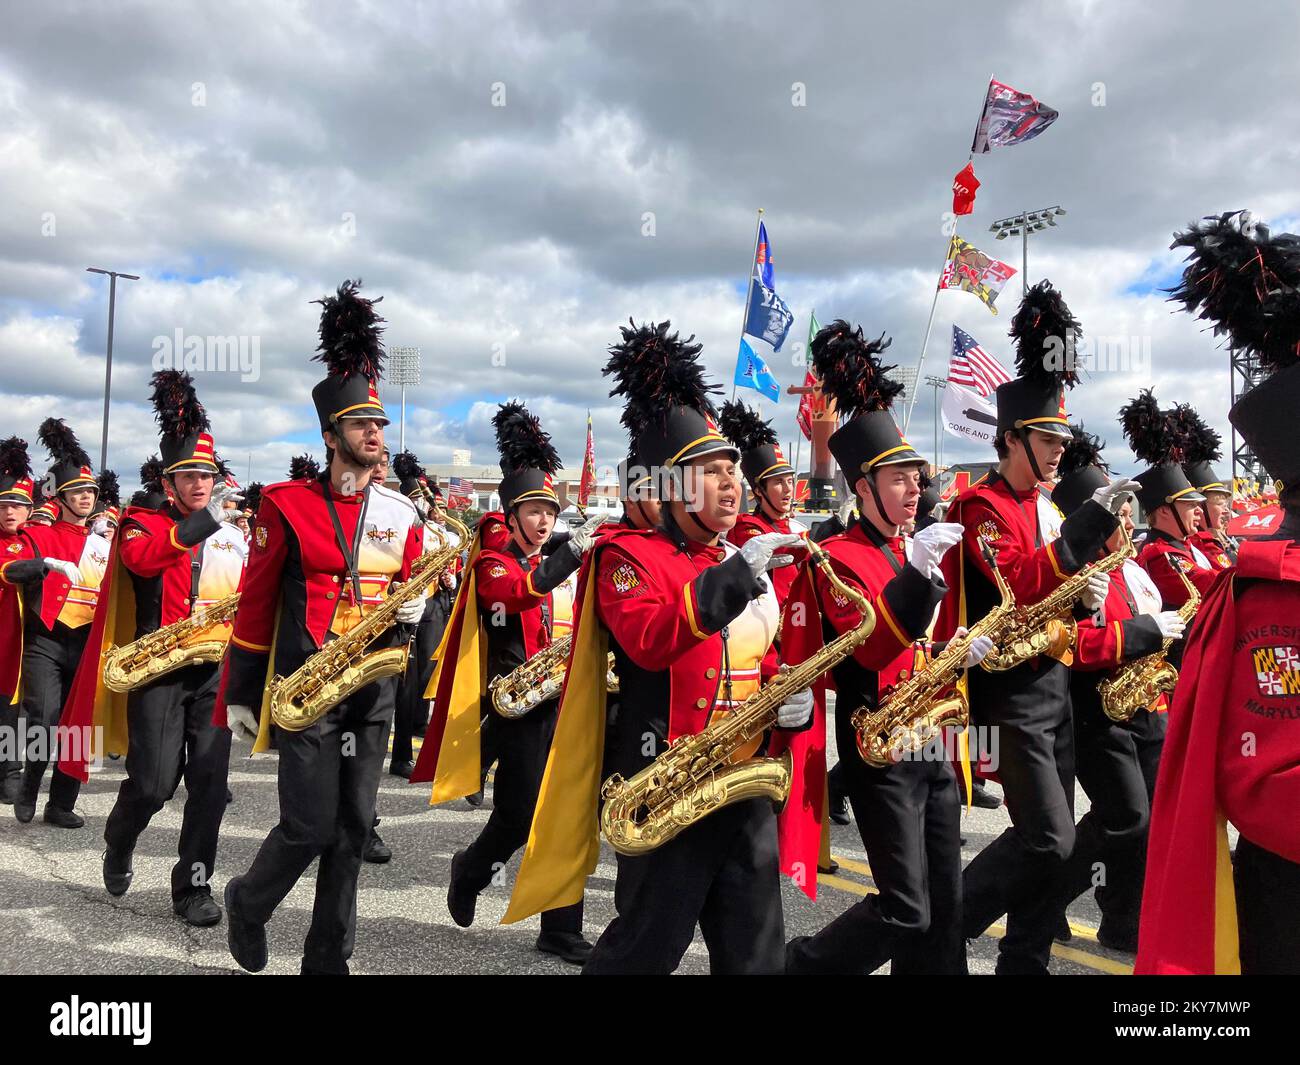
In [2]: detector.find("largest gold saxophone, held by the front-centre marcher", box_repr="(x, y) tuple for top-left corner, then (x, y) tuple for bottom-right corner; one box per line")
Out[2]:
(601, 541), (876, 856)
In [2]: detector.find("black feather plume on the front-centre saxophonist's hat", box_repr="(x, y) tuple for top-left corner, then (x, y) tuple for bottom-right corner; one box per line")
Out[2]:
(601, 319), (720, 437)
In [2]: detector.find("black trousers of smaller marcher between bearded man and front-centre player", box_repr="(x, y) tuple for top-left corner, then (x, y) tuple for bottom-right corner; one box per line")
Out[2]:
(459, 700), (582, 932)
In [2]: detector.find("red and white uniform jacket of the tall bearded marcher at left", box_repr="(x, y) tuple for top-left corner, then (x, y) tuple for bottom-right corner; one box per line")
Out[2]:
(213, 480), (423, 726)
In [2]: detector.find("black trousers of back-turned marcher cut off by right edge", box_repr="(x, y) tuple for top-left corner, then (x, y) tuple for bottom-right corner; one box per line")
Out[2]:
(1232, 837), (1300, 977)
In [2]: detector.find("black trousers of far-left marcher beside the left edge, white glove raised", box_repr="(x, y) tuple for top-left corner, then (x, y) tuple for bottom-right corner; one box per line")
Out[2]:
(22, 619), (90, 810)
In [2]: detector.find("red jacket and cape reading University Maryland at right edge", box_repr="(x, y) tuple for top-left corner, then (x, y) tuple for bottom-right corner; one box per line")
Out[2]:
(1135, 540), (1300, 974)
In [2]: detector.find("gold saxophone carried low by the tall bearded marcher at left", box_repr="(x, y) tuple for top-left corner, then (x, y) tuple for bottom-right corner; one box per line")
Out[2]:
(267, 515), (469, 732)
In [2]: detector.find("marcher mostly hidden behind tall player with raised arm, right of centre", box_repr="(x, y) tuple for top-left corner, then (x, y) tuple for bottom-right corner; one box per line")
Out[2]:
(1052, 427), (1186, 952)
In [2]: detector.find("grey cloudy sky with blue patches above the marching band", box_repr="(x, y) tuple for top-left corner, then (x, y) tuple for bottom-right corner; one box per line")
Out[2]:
(0, 0), (1300, 496)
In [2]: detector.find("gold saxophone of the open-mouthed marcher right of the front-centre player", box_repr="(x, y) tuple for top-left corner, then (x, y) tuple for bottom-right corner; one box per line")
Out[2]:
(852, 537), (1018, 769)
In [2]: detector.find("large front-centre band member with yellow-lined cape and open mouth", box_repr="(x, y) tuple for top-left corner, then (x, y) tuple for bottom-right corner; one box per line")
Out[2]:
(504, 321), (820, 974)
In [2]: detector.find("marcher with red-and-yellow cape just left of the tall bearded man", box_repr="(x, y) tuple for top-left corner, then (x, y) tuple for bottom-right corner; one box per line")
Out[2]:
(62, 369), (248, 927)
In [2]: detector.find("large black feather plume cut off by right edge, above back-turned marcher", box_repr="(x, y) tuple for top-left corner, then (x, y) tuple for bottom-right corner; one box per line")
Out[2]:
(1170, 211), (1300, 372)
